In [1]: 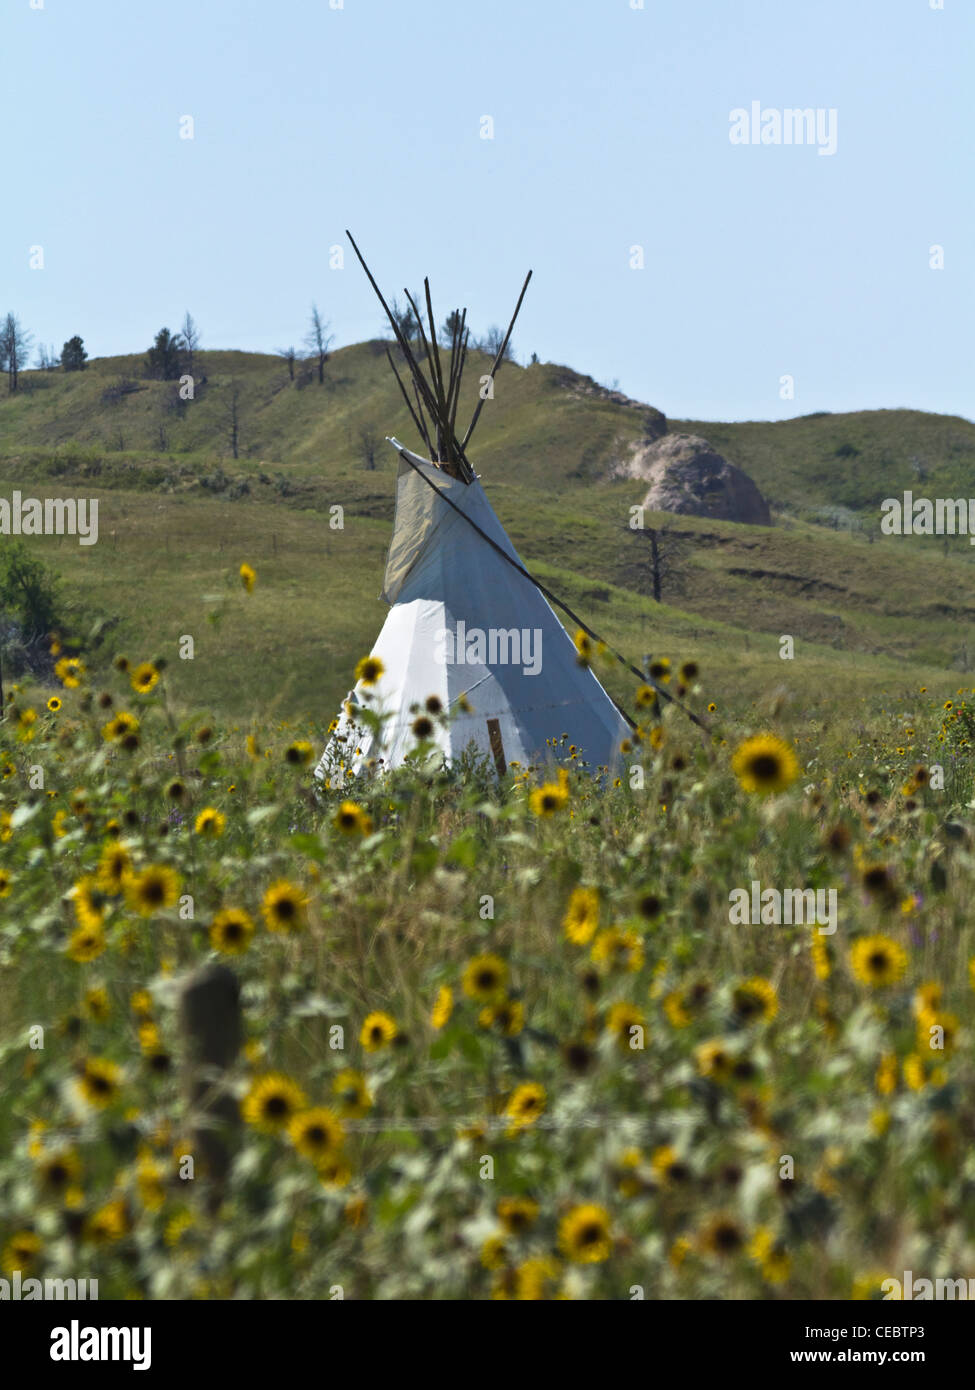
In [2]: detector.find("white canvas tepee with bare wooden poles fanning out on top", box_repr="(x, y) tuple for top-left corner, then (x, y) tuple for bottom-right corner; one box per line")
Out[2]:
(316, 234), (629, 784)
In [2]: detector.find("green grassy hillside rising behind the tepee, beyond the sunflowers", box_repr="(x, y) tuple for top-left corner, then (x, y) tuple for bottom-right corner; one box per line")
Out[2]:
(0, 342), (975, 721)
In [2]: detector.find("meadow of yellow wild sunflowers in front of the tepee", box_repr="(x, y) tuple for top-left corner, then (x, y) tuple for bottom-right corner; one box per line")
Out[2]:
(0, 622), (975, 1300)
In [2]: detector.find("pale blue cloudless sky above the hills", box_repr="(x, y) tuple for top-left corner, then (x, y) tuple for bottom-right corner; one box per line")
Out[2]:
(0, 0), (975, 420)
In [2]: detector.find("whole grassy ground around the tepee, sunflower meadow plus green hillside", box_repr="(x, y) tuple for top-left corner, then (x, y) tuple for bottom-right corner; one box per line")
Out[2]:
(0, 353), (975, 1300)
